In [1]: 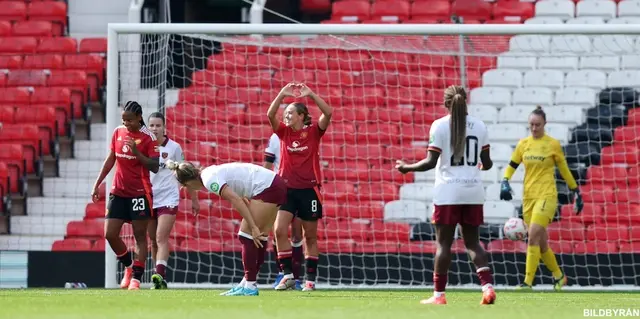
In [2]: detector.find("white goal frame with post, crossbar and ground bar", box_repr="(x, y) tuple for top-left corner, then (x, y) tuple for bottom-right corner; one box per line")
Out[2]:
(105, 23), (640, 290)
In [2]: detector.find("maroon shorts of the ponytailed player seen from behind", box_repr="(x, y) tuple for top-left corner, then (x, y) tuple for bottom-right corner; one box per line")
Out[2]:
(431, 205), (484, 226)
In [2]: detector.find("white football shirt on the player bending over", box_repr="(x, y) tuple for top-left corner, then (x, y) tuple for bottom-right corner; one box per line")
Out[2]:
(200, 163), (276, 199)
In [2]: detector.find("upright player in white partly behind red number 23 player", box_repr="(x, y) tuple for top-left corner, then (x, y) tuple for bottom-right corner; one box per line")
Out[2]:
(147, 112), (200, 289)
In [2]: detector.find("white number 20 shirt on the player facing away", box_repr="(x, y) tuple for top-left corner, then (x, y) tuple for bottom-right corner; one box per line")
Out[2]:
(429, 115), (489, 205)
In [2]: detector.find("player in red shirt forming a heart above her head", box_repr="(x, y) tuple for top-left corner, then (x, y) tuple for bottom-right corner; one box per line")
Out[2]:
(267, 83), (333, 291)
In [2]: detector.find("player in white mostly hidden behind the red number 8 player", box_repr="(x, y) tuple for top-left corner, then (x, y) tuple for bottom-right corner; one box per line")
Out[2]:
(264, 133), (304, 290)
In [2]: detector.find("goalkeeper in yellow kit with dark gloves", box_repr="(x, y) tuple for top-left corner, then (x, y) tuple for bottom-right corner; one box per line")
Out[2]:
(500, 106), (584, 290)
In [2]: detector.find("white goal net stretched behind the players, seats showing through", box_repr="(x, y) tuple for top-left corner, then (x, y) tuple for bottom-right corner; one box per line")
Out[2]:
(107, 24), (640, 289)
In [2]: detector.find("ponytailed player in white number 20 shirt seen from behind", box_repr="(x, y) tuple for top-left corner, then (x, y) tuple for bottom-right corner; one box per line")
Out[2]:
(396, 85), (496, 304)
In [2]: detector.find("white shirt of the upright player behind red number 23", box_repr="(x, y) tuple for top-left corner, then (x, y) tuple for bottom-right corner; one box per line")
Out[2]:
(151, 137), (184, 208)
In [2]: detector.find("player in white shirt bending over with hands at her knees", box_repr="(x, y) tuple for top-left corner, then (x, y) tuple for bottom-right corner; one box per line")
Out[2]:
(165, 161), (287, 296)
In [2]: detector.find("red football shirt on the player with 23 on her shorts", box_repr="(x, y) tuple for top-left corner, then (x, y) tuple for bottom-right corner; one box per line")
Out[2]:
(111, 126), (160, 198)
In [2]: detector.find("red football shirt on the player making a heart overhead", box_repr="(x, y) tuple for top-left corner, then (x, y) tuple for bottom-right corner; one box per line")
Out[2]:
(275, 122), (324, 189)
